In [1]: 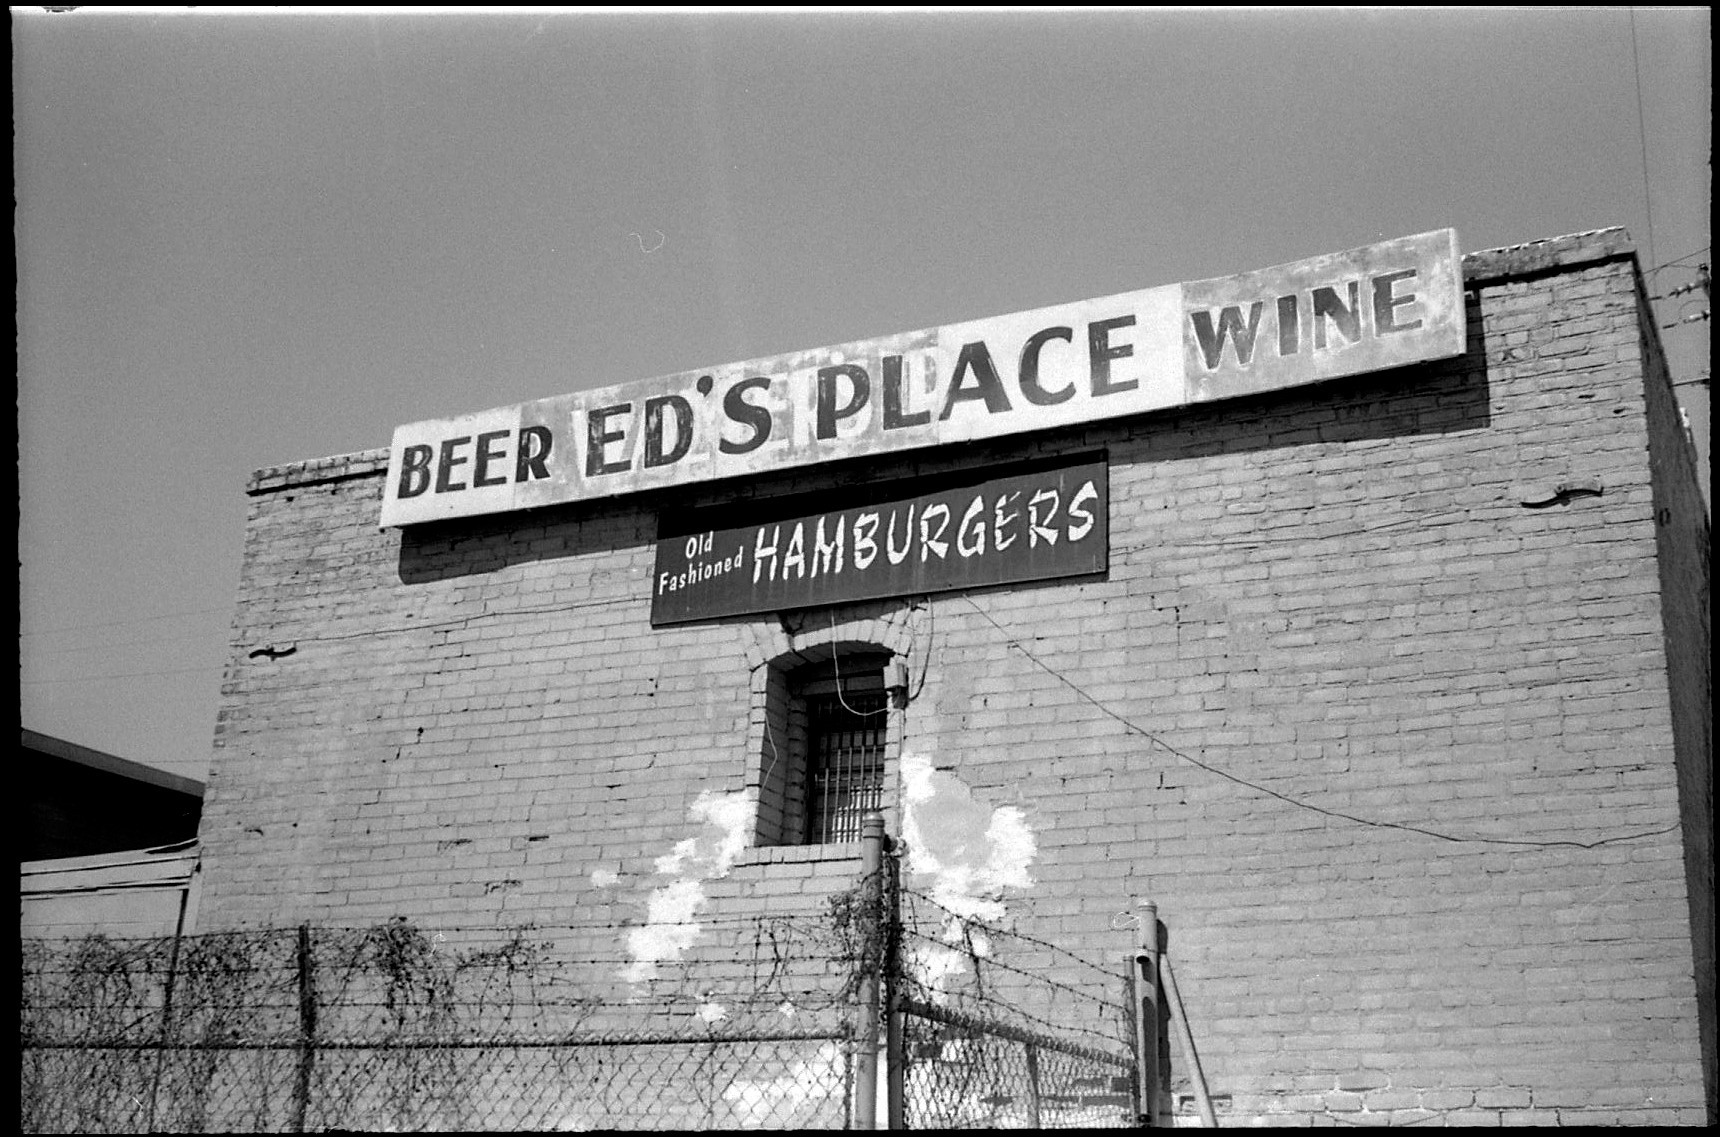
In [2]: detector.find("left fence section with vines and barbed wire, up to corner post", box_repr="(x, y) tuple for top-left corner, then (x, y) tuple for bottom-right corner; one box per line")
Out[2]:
(21, 919), (853, 1134)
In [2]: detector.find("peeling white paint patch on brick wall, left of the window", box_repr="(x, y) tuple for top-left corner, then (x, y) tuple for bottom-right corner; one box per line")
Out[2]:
(621, 790), (759, 984)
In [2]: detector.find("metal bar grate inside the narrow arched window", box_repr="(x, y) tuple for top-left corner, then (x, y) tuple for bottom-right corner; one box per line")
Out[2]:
(807, 690), (889, 845)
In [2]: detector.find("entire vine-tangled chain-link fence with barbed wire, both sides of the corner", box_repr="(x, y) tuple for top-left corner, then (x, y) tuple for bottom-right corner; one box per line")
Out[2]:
(19, 853), (1135, 1134)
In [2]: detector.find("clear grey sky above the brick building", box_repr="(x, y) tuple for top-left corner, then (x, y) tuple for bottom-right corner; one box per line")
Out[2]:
(12, 7), (1711, 779)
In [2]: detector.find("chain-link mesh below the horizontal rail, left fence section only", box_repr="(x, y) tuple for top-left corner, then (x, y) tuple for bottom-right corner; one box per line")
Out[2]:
(21, 1032), (851, 1134)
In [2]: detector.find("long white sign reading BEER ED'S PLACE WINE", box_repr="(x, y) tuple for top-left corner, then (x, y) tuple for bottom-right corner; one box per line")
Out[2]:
(382, 229), (1465, 526)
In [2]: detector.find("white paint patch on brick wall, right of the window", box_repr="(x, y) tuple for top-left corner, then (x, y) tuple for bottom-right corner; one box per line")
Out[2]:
(901, 753), (1039, 1001)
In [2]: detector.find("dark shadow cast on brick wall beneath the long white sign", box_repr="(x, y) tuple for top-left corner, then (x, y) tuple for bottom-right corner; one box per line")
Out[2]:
(399, 294), (1491, 585)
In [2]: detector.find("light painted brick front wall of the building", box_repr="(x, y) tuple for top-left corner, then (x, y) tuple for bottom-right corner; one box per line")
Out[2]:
(200, 230), (1713, 1123)
